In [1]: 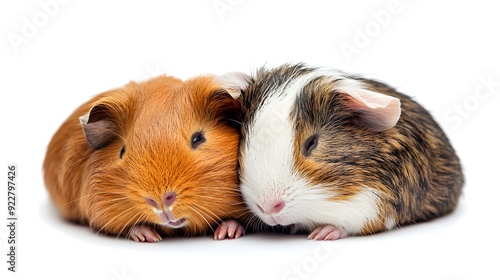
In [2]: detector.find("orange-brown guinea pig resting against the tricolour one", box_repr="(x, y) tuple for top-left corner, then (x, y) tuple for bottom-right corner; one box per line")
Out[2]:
(43, 76), (246, 242)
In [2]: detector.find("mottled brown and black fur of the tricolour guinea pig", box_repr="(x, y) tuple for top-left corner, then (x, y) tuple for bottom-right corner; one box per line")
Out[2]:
(241, 64), (464, 234)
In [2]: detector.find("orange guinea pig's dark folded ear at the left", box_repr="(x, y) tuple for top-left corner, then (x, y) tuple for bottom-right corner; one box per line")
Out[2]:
(80, 104), (117, 150)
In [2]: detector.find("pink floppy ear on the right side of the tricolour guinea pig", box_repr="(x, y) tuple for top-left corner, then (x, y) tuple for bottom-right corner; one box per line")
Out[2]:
(336, 87), (401, 131)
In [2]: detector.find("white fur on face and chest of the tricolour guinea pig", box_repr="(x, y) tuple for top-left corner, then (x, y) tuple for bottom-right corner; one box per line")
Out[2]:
(241, 70), (378, 234)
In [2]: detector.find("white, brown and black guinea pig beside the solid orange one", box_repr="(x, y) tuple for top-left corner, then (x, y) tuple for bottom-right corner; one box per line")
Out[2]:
(218, 64), (464, 240)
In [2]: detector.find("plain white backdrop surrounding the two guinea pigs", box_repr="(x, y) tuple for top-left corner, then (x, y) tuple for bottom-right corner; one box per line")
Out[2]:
(0, 0), (500, 280)
